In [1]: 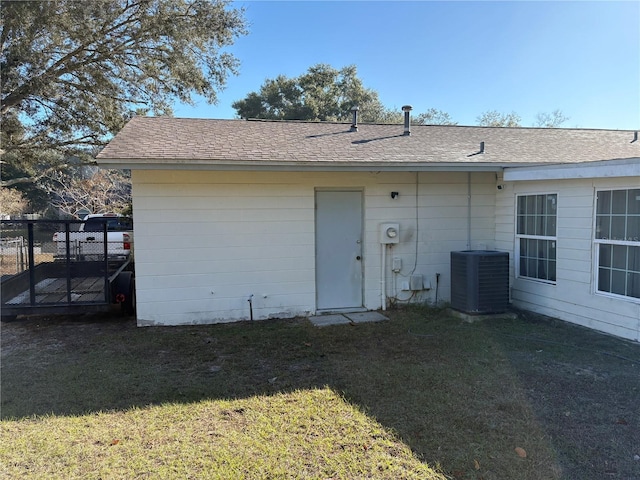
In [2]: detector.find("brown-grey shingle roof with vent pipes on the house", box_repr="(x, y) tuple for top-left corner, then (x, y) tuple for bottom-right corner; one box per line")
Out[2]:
(97, 117), (640, 172)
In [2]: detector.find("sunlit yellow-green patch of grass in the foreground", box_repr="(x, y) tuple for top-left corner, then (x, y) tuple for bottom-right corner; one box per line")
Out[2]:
(0, 388), (442, 479)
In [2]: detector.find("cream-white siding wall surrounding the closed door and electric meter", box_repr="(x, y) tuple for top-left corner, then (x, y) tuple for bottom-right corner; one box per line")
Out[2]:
(133, 170), (498, 325)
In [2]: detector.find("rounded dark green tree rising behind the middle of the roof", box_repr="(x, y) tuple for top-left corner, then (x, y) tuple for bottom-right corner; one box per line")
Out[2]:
(232, 64), (384, 122)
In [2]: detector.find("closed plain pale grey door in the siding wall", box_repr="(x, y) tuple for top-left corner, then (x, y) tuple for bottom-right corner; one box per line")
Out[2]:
(316, 191), (362, 310)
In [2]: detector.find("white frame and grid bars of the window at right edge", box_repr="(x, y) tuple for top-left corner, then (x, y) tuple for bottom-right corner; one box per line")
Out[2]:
(592, 186), (640, 303)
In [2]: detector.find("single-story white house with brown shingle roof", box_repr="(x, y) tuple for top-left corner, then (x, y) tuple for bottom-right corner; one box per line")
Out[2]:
(97, 113), (640, 341)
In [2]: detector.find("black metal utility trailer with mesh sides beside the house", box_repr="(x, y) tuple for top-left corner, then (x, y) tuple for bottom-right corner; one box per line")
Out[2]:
(0, 220), (135, 320)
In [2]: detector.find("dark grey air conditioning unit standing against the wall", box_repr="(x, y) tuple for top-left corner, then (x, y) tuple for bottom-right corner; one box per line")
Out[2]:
(451, 250), (509, 314)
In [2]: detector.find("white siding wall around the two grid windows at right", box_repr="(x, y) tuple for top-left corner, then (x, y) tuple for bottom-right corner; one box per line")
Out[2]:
(496, 177), (640, 340)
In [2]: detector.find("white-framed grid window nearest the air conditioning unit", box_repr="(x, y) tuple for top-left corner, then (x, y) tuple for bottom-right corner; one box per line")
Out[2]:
(516, 193), (558, 282)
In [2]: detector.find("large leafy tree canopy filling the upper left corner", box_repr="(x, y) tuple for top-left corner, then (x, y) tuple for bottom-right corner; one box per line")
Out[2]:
(0, 0), (246, 189)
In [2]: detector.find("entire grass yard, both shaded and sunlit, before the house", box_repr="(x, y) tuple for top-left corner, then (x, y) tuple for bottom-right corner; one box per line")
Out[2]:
(0, 308), (640, 480)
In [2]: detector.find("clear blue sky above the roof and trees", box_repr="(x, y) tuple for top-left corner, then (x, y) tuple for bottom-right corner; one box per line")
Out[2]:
(175, 0), (640, 130)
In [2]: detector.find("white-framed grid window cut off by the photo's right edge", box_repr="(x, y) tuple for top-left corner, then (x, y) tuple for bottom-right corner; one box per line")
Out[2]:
(594, 188), (640, 298)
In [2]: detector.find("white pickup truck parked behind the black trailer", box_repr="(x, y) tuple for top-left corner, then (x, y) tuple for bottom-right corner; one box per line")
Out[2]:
(53, 213), (133, 260)
